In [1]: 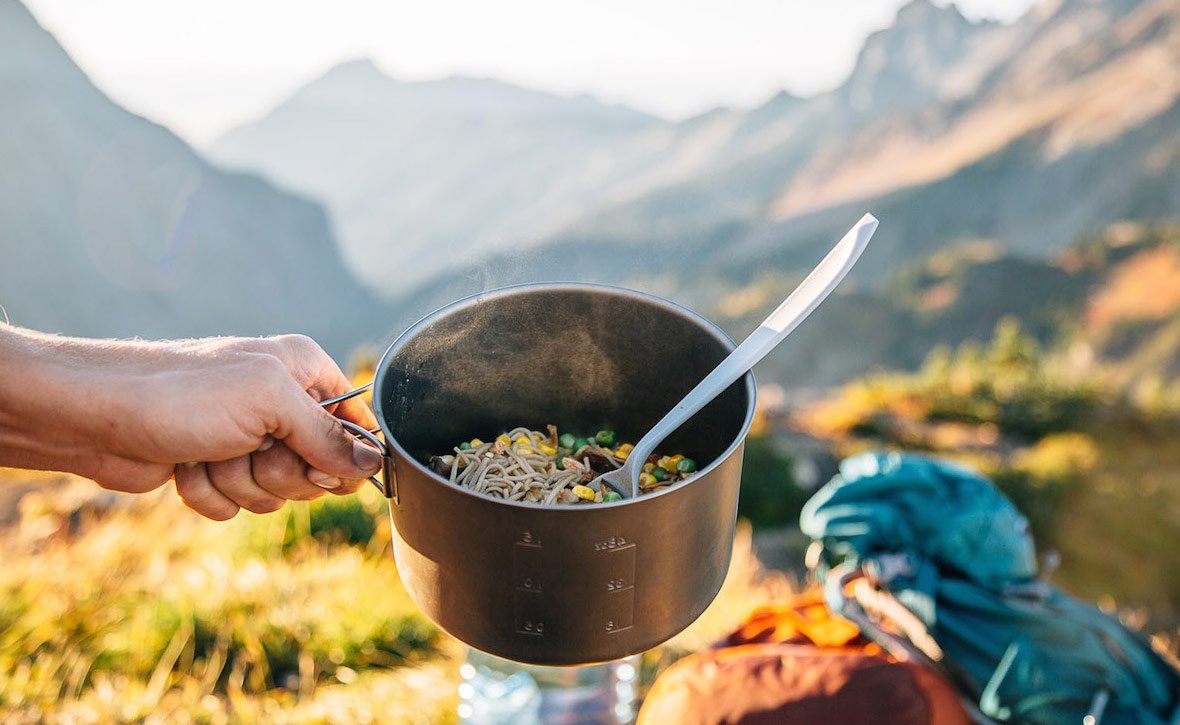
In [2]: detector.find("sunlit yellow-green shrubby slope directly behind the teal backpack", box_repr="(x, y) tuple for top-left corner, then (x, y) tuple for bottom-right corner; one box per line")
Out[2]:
(795, 320), (1180, 627)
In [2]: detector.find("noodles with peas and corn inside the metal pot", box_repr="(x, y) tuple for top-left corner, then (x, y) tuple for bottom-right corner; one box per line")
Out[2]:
(431, 425), (696, 504)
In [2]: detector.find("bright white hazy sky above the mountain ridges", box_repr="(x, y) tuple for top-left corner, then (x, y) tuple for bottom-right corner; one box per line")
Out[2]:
(18, 0), (1035, 145)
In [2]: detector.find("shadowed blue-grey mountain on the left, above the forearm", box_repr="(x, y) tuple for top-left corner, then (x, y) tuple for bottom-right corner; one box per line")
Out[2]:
(0, 0), (384, 354)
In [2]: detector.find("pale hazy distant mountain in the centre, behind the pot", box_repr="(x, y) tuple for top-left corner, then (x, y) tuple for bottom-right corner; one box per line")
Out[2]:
(209, 60), (669, 292)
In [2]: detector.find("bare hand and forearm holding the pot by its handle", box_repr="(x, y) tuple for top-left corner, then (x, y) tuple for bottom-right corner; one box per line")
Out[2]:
(0, 326), (381, 520)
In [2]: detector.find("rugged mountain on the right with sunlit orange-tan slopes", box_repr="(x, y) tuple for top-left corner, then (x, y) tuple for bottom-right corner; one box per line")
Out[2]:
(555, 0), (1180, 275)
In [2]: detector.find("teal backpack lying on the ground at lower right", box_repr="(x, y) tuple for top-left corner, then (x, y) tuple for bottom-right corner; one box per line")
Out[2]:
(800, 453), (1180, 725)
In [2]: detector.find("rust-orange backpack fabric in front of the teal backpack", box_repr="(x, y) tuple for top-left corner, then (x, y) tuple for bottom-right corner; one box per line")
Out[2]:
(637, 592), (970, 725)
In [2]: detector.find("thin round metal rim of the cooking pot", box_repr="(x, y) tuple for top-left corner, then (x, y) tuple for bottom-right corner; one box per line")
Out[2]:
(373, 282), (758, 512)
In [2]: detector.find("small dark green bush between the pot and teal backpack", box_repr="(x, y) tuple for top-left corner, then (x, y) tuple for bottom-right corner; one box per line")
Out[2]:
(738, 436), (808, 528)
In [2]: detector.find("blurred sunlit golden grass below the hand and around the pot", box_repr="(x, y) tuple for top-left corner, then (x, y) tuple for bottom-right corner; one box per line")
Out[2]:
(0, 470), (791, 723)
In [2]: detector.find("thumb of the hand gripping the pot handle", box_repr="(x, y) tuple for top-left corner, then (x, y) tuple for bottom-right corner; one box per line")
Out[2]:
(276, 385), (381, 481)
